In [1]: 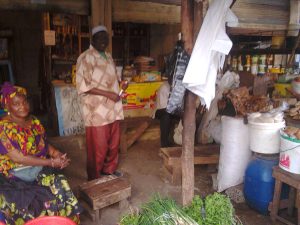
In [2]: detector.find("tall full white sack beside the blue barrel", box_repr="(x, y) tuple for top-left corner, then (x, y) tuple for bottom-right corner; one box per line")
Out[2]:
(217, 116), (251, 192)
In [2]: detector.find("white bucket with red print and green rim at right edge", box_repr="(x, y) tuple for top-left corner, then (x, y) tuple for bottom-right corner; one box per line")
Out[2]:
(279, 130), (300, 174)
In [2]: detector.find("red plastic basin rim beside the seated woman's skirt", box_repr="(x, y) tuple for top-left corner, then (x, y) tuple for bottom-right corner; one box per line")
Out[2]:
(24, 216), (76, 225)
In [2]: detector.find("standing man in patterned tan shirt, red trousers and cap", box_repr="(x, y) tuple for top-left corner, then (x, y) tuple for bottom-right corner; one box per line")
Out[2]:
(76, 25), (127, 180)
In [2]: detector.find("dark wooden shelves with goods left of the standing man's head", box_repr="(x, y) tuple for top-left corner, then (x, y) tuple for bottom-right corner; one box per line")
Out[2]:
(48, 13), (90, 81)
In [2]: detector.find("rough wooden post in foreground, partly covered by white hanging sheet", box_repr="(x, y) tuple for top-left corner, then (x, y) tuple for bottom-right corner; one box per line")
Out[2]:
(181, 0), (196, 205)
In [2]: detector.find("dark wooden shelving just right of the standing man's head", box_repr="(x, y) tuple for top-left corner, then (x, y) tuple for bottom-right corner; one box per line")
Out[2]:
(112, 22), (150, 67)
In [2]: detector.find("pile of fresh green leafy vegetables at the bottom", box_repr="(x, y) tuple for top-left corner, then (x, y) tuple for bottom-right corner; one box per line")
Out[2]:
(120, 193), (242, 225)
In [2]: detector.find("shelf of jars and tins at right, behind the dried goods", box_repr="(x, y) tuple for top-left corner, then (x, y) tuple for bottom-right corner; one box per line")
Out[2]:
(227, 51), (299, 97)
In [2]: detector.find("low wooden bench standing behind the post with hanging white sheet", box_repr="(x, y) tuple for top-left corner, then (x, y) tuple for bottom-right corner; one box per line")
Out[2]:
(160, 144), (220, 185)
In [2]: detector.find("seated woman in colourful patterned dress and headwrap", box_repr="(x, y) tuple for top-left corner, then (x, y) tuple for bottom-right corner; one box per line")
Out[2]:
(0, 83), (81, 225)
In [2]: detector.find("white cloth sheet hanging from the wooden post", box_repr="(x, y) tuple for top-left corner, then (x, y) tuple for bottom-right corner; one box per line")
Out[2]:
(183, 0), (238, 108)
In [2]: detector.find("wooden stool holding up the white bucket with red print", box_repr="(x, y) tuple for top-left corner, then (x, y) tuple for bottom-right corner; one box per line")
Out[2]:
(269, 166), (300, 225)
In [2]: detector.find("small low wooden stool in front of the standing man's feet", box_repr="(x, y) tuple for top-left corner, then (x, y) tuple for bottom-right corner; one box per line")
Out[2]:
(79, 175), (131, 224)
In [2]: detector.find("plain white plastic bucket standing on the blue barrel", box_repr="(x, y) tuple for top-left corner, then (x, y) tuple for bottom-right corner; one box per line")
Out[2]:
(249, 121), (285, 154)
